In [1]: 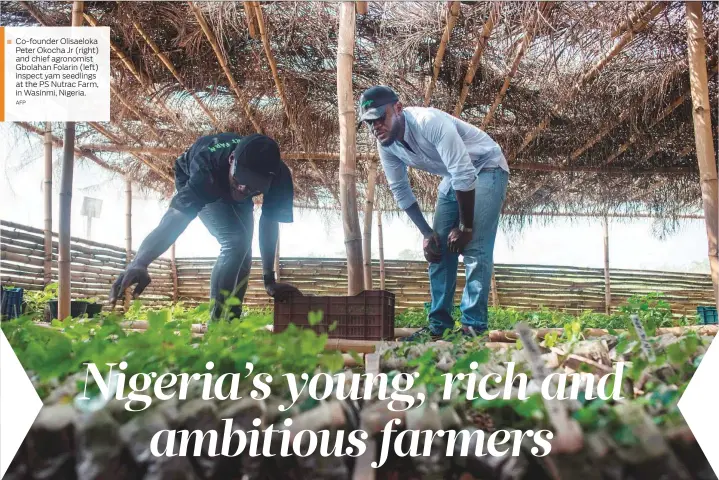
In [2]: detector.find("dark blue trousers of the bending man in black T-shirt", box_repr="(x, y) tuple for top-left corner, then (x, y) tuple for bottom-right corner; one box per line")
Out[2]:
(198, 200), (254, 321)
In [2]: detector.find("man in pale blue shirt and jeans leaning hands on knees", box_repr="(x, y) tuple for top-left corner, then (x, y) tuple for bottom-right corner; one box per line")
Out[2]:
(360, 86), (509, 341)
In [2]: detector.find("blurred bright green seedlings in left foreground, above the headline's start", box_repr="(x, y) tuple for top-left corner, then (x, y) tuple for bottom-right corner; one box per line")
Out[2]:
(3, 304), (343, 404)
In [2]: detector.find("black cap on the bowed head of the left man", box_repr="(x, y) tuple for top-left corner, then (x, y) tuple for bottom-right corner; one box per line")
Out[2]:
(232, 133), (282, 193)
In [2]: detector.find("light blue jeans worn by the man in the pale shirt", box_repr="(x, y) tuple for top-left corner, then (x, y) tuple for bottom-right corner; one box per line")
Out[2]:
(429, 168), (509, 335)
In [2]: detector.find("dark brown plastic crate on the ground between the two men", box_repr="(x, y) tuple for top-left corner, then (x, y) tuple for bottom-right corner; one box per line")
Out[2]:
(273, 290), (395, 340)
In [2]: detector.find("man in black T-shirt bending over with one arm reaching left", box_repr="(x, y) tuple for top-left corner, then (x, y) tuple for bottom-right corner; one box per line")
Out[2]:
(110, 133), (299, 321)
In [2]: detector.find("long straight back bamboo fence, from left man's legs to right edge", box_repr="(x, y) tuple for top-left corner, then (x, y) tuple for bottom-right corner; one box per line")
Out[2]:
(177, 258), (714, 315)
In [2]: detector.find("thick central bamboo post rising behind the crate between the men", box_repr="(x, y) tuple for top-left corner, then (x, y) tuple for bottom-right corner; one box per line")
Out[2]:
(337, 2), (363, 295)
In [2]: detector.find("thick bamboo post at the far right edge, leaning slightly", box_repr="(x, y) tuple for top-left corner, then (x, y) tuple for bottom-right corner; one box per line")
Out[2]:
(686, 1), (719, 308)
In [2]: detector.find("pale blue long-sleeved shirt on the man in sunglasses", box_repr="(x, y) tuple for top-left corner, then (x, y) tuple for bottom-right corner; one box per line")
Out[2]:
(377, 107), (509, 210)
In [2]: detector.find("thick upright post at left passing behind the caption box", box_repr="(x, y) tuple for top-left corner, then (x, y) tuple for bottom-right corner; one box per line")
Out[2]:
(57, 0), (84, 320)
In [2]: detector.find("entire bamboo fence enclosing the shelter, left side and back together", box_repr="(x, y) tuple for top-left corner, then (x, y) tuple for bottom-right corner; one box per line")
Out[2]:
(0, 221), (714, 315)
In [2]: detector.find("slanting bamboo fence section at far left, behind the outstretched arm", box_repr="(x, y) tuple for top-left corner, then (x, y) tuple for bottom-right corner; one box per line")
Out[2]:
(0, 221), (173, 305)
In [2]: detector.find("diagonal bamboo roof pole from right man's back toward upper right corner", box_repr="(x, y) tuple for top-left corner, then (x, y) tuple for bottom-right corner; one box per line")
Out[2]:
(507, 2), (669, 163)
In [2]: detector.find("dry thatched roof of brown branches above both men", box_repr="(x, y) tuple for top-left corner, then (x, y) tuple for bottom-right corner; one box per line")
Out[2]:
(2, 2), (719, 229)
